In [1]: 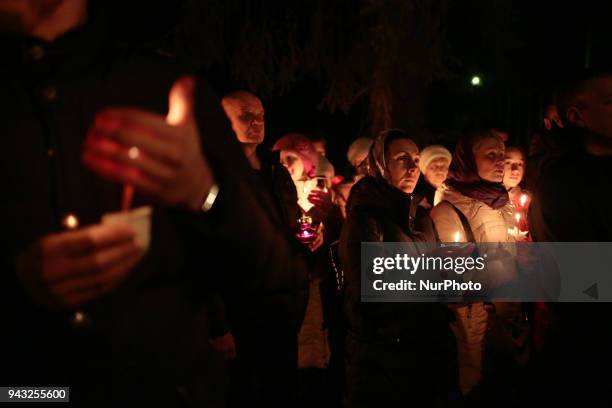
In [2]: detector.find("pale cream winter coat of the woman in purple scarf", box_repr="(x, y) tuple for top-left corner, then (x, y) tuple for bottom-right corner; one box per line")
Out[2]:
(430, 185), (520, 394)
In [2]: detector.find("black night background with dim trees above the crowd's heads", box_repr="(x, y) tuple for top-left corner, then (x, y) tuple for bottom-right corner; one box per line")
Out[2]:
(105, 0), (612, 175)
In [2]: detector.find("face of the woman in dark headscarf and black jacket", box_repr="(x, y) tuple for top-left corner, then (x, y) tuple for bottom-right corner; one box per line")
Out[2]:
(385, 139), (421, 194)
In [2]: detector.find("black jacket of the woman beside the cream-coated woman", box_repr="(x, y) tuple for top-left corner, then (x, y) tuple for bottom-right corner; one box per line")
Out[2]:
(340, 177), (450, 347)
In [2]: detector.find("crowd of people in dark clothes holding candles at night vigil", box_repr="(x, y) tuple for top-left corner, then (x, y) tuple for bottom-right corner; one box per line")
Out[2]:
(0, 0), (612, 407)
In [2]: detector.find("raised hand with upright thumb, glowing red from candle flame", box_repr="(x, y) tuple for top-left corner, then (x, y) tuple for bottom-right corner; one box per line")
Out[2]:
(83, 77), (214, 211)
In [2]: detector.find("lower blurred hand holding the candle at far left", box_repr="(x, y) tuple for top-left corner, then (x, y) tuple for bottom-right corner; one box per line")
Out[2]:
(16, 223), (143, 308)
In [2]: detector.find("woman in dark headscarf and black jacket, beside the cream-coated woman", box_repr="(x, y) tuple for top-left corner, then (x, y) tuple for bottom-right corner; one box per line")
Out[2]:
(340, 130), (456, 407)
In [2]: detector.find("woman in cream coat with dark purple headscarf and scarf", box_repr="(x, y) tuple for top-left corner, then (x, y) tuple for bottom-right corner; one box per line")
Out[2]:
(431, 130), (524, 402)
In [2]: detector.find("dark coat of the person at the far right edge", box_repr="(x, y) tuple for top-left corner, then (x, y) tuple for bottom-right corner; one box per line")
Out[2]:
(529, 139), (612, 406)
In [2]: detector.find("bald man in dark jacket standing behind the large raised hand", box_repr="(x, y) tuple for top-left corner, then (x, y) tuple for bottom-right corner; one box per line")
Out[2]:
(221, 91), (310, 406)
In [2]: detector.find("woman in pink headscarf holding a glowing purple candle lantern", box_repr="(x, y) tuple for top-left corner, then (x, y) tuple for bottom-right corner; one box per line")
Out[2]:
(273, 133), (350, 405)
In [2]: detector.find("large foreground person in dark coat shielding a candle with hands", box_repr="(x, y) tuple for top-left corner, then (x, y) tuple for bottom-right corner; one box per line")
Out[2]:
(0, 0), (310, 407)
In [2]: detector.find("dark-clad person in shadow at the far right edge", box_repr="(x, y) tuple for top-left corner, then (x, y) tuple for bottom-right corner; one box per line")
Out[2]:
(529, 71), (612, 406)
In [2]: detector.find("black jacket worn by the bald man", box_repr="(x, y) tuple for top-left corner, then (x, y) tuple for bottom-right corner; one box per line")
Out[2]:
(211, 149), (312, 342)
